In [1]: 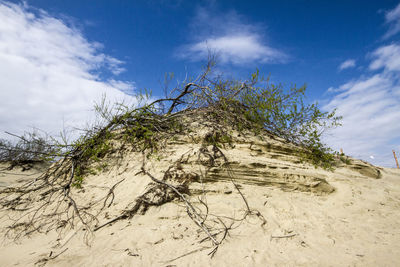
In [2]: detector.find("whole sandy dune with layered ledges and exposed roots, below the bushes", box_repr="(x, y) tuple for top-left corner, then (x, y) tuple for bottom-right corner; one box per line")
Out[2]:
(0, 110), (400, 266)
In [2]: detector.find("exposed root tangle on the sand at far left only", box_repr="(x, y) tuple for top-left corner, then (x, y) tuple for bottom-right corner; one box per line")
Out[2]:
(0, 159), (123, 244)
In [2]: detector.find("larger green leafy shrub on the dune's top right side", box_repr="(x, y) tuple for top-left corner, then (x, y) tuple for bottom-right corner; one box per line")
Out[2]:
(183, 70), (341, 169)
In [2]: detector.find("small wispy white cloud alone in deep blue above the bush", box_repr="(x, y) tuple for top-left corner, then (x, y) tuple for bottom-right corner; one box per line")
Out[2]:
(178, 8), (287, 65)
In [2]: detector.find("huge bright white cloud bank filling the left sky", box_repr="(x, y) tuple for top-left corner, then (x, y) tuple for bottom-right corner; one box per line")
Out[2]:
(0, 2), (134, 139)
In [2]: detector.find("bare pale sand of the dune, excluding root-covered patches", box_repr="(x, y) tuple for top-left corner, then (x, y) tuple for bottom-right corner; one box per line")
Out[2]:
(0, 131), (400, 266)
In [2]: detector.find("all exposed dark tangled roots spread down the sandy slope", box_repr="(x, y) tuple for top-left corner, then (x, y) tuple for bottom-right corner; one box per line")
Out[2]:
(0, 129), (266, 257)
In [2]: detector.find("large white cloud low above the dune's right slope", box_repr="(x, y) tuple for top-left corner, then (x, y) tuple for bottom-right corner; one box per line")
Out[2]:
(323, 45), (400, 167)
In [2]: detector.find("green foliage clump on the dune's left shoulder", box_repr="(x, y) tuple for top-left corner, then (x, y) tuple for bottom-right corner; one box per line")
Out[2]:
(71, 94), (188, 188)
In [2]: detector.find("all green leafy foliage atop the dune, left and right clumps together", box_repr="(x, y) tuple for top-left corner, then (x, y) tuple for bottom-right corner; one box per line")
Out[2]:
(79, 66), (341, 172)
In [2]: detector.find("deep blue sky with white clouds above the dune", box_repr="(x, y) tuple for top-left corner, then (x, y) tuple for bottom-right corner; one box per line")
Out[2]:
(0, 0), (400, 167)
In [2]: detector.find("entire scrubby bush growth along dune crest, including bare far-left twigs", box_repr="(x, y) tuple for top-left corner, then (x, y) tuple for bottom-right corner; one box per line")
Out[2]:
(0, 59), (341, 173)
